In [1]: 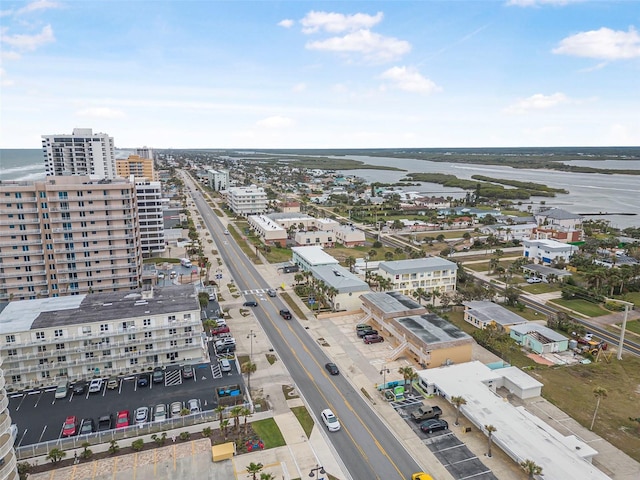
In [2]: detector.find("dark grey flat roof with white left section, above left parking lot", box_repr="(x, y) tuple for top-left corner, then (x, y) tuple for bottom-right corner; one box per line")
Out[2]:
(0, 285), (200, 334)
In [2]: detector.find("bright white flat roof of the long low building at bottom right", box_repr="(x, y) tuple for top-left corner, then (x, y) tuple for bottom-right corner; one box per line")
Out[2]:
(418, 361), (609, 480)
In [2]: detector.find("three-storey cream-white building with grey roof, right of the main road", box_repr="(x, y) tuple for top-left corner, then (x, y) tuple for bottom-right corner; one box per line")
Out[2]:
(377, 257), (458, 296)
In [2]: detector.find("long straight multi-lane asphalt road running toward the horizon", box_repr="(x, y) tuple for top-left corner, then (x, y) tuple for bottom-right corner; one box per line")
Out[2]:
(185, 175), (420, 480)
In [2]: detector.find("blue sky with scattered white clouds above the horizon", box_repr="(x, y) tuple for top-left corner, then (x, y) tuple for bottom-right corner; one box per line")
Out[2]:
(0, 0), (640, 148)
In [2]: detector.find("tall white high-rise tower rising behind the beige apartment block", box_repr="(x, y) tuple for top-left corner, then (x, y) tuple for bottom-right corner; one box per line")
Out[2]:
(42, 128), (116, 178)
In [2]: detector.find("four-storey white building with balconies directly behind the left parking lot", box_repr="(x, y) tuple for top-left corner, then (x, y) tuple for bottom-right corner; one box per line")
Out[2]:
(0, 285), (208, 389)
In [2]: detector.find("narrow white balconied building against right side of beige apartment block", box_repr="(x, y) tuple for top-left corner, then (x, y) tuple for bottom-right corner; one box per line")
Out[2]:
(136, 182), (166, 257)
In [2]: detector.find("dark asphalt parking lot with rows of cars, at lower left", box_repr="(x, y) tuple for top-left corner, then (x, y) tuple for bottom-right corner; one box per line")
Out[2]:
(8, 356), (244, 446)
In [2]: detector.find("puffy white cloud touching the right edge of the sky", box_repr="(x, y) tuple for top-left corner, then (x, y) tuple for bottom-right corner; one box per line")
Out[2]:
(553, 27), (640, 60)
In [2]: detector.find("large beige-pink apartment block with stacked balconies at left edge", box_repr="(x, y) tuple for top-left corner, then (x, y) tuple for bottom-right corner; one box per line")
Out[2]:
(0, 175), (142, 301)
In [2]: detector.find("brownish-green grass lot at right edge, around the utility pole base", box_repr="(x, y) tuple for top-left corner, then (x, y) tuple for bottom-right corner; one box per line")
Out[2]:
(530, 355), (640, 461)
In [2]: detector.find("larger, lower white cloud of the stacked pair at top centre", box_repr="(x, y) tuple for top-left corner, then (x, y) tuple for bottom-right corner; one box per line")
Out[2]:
(306, 30), (411, 62)
